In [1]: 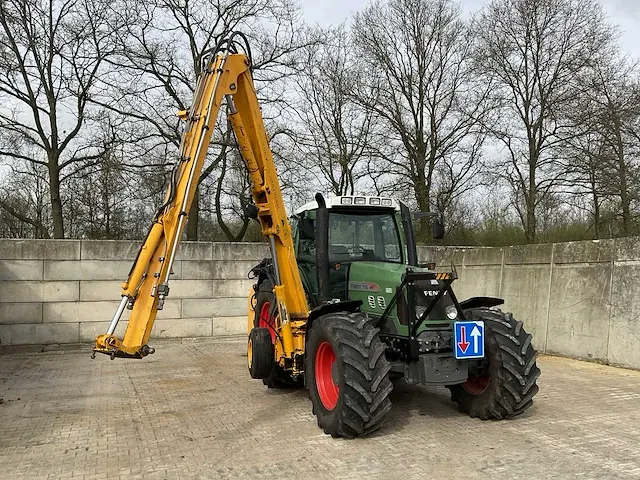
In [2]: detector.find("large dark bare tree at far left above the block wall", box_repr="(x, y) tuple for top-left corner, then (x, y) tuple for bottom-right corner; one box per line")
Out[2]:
(0, 0), (121, 238)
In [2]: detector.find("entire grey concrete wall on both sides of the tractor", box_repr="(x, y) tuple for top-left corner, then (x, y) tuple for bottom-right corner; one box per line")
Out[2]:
(0, 238), (640, 368)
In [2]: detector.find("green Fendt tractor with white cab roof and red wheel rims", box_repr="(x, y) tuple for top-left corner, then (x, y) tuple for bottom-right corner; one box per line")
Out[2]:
(252, 194), (540, 437)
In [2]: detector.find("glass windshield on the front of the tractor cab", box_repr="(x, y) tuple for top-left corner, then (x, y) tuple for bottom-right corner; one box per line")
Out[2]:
(329, 212), (402, 263)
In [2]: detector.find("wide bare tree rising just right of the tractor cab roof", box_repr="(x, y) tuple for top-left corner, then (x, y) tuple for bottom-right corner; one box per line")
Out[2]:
(354, 0), (487, 237)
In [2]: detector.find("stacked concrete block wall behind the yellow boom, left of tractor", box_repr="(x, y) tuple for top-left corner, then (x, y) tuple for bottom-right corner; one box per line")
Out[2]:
(0, 239), (268, 346)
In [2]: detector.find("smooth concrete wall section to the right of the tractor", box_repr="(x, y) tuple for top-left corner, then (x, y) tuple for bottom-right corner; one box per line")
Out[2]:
(419, 238), (640, 368)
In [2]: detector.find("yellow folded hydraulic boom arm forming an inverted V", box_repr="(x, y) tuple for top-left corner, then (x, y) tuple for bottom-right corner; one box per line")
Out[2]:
(94, 40), (309, 369)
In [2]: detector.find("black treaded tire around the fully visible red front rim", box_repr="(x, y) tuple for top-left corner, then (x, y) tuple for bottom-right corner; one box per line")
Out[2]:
(305, 312), (393, 437)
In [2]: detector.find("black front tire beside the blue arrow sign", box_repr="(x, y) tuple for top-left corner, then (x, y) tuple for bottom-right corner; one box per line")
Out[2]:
(449, 308), (540, 420)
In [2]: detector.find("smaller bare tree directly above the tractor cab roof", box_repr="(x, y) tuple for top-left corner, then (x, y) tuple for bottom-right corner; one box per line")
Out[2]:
(293, 25), (378, 195)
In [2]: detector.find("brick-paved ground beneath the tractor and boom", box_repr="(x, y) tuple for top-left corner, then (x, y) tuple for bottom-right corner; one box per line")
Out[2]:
(0, 342), (640, 480)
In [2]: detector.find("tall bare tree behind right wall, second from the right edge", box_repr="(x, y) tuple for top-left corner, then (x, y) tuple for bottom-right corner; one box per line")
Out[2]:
(475, 0), (614, 242)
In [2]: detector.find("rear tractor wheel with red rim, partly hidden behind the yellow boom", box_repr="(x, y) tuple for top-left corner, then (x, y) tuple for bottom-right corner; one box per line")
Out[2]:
(253, 279), (301, 388)
